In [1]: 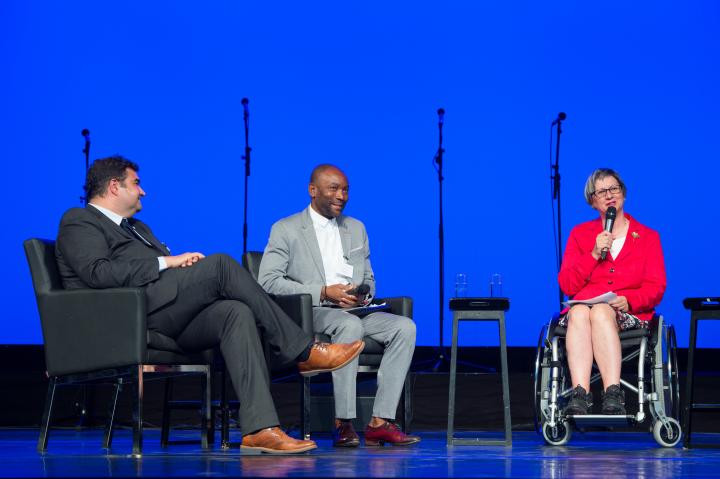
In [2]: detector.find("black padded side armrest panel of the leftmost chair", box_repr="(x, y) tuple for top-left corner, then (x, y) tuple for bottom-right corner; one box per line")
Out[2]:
(38, 288), (147, 376)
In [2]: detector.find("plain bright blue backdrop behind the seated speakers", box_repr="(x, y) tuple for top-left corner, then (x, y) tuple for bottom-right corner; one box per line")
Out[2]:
(0, 0), (720, 346)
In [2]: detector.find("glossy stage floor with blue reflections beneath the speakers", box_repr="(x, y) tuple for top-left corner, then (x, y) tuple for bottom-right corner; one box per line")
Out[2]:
(0, 429), (720, 478)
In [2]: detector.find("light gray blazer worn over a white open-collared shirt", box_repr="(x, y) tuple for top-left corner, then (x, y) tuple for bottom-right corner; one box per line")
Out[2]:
(258, 206), (375, 306)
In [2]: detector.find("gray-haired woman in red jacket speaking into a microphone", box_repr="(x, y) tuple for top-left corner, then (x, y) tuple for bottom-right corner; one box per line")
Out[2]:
(558, 168), (666, 414)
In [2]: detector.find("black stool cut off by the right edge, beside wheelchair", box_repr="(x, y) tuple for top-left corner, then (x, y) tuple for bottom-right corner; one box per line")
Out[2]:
(682, 298), (720, 448)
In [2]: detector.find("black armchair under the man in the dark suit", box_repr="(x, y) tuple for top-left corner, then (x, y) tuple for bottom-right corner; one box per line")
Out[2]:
(23, 239), (211, 456)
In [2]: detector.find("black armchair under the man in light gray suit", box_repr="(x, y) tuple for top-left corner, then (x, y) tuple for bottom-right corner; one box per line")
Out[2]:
(243, 251), (413, 438)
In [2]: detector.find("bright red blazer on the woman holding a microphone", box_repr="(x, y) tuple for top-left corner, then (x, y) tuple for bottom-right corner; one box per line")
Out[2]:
(558, 213), (667, 321)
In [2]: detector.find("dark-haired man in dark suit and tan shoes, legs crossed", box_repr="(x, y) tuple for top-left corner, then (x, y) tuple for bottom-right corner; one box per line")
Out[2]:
(56, 156), (363, 453)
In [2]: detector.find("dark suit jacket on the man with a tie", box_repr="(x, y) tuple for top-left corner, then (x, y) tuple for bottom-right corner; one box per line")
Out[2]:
(55, 205), (177, 313)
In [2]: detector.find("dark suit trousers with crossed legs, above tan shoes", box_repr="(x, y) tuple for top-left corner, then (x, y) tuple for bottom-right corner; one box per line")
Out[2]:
(148, 254), (312, 434)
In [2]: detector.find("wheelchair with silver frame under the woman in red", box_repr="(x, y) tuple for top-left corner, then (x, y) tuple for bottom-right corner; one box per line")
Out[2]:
(534, 315), (682, 447)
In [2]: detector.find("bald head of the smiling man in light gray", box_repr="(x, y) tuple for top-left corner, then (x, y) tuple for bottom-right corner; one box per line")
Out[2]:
(308, 164), (350, 218)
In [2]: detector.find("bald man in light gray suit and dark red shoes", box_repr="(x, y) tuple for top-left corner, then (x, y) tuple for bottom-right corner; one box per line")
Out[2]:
(258, 165), (420, 447)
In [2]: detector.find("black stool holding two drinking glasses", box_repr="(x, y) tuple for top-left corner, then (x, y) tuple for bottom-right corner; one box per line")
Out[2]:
(447, 298), (512, 446)
